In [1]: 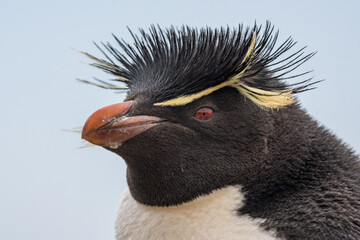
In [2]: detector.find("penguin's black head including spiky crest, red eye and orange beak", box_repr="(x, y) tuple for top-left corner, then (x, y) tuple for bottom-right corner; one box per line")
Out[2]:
(82, 23), (313, 206)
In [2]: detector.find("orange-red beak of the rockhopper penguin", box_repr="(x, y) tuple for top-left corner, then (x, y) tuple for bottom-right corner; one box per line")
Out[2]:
(81, 101), (162, 148)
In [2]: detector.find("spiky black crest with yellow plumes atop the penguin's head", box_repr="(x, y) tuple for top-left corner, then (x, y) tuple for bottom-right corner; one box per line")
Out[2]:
(82, 22), (314, 107)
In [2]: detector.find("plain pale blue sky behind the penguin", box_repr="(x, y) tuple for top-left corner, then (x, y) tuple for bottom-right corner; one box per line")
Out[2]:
(0, 0), (360, 240)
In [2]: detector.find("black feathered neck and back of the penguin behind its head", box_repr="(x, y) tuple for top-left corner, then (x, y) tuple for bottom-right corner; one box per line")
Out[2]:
(239, 106), (360, 239)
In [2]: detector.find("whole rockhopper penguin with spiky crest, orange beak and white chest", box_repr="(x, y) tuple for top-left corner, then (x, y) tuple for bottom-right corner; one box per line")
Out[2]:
(82, 23), (360, 240)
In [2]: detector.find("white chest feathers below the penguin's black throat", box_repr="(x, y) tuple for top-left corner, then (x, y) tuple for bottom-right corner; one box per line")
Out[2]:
(115, 186), (276, 240)
